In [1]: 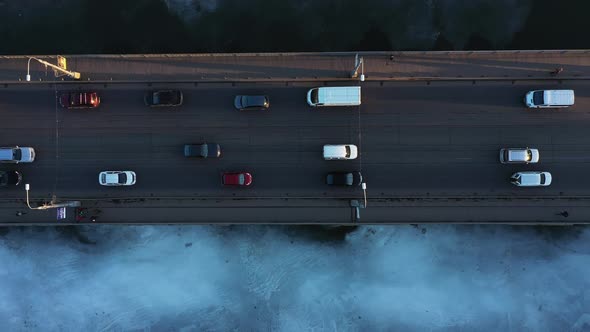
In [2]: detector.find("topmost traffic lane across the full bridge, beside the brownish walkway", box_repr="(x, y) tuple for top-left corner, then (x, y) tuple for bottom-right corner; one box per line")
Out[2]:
(0, 81), (590, 126)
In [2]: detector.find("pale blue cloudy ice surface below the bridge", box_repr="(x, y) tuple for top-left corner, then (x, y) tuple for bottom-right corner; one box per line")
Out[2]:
(0, 225), (590, 331)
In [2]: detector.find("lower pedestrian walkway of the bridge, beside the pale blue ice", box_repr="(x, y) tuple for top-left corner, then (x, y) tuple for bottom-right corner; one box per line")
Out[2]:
(0, 198), (590, 225)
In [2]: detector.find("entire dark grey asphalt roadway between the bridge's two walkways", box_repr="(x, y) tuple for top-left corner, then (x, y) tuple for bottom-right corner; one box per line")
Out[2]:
(0, 80), (590, 199)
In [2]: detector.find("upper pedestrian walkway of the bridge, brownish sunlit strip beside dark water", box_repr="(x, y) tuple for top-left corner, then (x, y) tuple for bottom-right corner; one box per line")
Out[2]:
(0, 50), (590, 83)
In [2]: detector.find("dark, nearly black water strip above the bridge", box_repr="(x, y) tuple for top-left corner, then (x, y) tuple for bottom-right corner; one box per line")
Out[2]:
(0, 0), (590, 54)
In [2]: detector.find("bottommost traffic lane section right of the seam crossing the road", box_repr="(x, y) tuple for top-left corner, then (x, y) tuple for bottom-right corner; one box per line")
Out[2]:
(363, 163), (590, 198)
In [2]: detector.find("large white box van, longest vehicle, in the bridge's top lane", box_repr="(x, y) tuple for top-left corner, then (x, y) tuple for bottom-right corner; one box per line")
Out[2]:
(307, 86), (361, 107)
